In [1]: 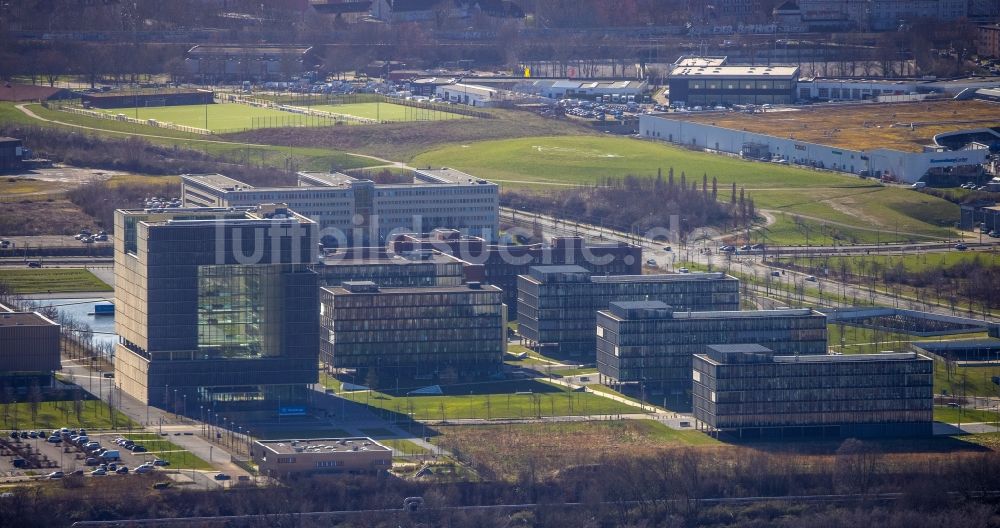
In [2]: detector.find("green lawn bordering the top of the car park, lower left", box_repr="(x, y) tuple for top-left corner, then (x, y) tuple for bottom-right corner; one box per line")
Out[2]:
(0, 400), (139, 430)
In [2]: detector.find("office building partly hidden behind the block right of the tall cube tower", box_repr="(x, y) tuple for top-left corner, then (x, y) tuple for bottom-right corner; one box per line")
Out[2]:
(314, 248), (466, 288)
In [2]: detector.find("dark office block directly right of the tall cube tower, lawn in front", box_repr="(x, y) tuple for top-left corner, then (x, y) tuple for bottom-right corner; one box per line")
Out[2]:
(320, 281), (507, 385)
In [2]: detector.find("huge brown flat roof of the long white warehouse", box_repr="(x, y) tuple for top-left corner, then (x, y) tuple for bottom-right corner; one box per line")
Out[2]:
(658, 100), (1000, 152)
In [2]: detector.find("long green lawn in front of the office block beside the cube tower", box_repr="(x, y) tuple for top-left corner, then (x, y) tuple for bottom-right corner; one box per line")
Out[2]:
(342, 380), (639, 420)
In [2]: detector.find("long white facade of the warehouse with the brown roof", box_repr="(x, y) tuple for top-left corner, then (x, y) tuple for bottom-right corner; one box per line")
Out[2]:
(639, 115), (989, 183)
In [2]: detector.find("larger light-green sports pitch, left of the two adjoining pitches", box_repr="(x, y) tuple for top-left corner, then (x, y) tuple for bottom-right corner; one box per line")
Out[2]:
(94, 103), (331, 133)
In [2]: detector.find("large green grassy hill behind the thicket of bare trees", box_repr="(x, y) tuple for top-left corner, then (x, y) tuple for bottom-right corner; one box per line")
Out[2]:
(412, 136), (958, 238)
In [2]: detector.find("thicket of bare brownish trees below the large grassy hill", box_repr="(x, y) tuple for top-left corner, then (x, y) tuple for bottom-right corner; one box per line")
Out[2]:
(501, 168), (756, 234)
